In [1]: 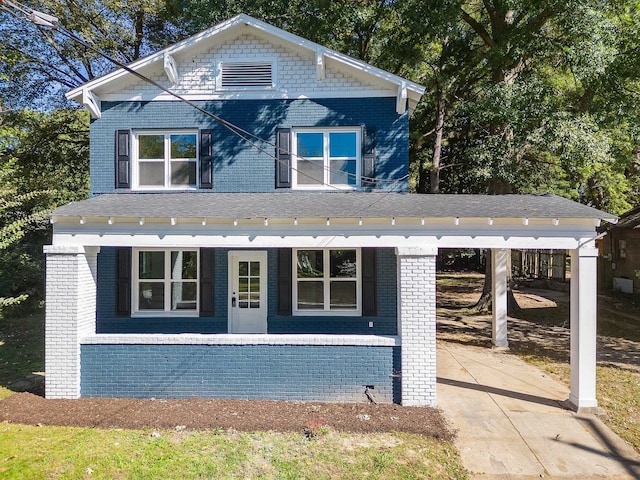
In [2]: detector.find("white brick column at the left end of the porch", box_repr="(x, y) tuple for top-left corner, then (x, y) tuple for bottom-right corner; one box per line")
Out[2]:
(44, 245), (100, 398)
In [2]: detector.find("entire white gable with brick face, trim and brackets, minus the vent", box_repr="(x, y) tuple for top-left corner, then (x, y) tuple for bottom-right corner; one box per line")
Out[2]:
(67, 14), (425, 117)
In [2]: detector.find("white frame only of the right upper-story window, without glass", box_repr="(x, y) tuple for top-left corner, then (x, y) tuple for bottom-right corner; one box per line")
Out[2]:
(291, 126), (362, 190)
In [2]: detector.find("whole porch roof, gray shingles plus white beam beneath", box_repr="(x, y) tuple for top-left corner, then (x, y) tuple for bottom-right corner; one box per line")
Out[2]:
(52, 193), (616, 249)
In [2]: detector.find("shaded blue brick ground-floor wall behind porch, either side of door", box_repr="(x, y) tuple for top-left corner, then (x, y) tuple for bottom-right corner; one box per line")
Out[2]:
(96, 247), (397, 335)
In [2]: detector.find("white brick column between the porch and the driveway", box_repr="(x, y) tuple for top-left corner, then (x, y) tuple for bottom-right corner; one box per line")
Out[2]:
(396, 247), (438, 407)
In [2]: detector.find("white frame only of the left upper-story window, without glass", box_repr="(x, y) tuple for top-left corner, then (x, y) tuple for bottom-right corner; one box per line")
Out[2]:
(131, 129), (200, 191)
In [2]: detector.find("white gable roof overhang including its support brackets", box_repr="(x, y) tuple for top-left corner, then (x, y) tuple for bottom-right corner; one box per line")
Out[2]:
(66, 14), (425, 113)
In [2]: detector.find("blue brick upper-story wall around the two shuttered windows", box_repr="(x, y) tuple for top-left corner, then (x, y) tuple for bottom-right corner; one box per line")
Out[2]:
(90, 97), (409, 194)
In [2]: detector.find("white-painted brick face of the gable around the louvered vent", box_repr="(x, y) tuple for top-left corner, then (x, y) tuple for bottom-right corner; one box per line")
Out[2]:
(102, 35), (382, 100)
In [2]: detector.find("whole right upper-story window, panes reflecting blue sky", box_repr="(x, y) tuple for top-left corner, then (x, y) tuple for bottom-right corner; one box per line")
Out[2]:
(291, 127), (362, 190)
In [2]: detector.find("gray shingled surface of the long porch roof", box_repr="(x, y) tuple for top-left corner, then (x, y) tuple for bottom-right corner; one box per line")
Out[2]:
(53, 192), (616, 222)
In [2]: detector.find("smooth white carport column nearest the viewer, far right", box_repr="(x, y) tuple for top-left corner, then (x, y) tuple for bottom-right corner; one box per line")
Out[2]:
(569, 245), (598, 411)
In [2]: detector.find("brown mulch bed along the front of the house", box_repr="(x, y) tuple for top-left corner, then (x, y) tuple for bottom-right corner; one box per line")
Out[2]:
(0, 393), (453, 440)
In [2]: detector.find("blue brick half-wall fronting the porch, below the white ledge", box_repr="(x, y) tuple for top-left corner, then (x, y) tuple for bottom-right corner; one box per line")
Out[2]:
(81, 345), (400, 403)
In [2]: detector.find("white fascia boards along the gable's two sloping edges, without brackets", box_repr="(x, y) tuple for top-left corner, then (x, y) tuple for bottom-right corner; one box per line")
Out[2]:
(66, 14), (426, 105)
